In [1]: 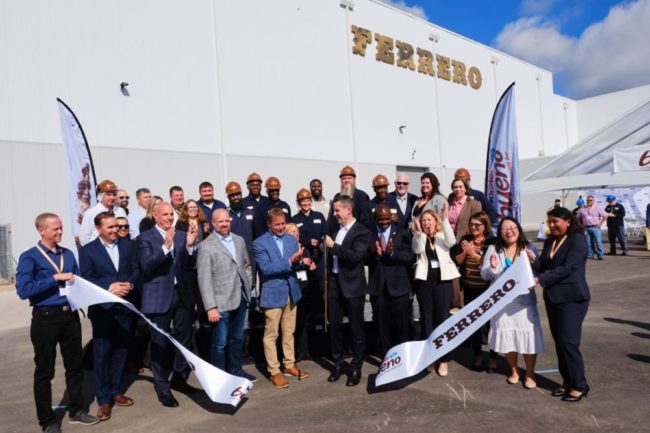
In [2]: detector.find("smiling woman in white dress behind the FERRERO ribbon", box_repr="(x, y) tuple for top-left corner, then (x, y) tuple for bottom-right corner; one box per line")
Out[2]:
(481, 217), (544, 389)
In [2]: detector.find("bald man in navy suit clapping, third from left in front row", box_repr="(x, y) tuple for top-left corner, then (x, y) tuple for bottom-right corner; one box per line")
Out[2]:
(138, 202), (196, 407)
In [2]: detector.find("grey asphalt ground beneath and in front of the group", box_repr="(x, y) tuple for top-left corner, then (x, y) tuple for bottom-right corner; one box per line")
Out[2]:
(0, 238), (650, 433)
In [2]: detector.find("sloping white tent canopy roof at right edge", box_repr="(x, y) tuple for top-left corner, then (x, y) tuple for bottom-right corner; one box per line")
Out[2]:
(521, 100), (650, 194)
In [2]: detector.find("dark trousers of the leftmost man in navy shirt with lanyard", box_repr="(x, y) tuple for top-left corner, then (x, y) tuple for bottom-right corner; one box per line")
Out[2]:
(30, 307), (83, 428)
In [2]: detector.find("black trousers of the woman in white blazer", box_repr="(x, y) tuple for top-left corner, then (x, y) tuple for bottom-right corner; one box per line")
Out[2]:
(415, 280), (453, 362)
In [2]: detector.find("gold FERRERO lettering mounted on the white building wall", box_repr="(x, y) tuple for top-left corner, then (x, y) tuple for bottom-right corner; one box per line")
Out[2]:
(352, 25), (483, 89)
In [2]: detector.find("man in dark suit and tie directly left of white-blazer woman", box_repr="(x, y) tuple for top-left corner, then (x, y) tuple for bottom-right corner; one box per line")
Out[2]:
(368, 204), (415, 354)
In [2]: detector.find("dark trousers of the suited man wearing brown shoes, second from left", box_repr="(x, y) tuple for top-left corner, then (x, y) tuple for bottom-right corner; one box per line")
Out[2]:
(90, 312), (133, 405)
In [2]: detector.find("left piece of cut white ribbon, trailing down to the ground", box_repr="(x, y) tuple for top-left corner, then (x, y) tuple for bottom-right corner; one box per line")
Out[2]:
(66, 276), (253, 407)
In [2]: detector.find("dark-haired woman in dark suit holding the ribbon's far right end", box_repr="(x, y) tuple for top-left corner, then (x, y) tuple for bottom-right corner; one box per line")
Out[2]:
(536, 207), (591, 402)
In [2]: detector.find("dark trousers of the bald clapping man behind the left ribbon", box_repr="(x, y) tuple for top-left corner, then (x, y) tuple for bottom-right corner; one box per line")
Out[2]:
(147, 291), (194, 394)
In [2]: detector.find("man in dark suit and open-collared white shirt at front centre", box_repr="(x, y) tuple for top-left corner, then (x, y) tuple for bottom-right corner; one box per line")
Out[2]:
(325, 195), (371, 386)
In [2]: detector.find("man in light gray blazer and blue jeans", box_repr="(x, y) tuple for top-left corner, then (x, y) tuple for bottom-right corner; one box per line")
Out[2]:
(196, 209), (257, 382)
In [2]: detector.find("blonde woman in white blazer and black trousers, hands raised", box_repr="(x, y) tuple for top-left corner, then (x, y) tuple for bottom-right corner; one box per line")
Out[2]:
(412, 207), (460, 376)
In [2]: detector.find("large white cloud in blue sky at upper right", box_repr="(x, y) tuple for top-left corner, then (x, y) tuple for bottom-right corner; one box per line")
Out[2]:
(494, 0), (650, 98)
